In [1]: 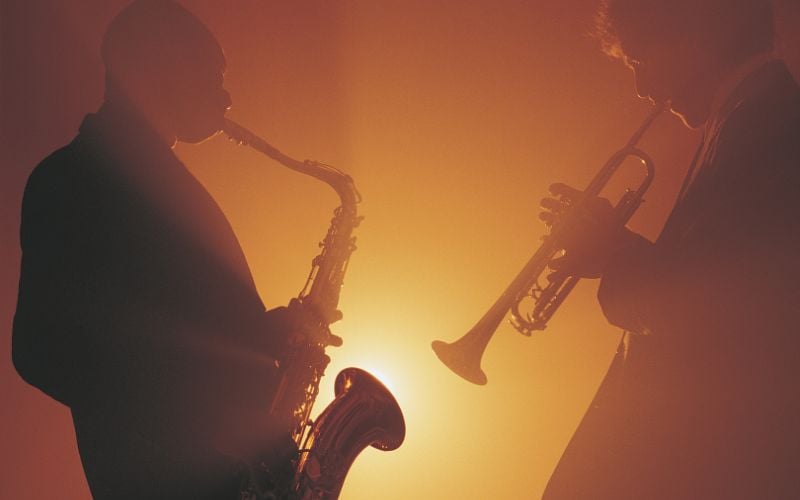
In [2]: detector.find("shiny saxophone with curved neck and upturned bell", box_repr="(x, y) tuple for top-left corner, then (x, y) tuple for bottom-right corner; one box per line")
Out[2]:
(224, 119), (405, 500)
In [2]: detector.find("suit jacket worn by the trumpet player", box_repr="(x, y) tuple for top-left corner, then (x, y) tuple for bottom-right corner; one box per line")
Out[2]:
(545, 61), (800, 499)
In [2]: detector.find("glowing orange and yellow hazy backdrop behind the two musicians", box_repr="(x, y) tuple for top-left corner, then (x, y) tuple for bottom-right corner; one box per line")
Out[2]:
(0, 0), (800, 500)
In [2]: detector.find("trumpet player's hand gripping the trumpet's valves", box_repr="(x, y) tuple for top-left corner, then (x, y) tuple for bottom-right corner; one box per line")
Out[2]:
(539, 183), (632, 278)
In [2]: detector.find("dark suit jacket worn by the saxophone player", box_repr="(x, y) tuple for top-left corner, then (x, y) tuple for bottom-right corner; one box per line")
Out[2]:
(13, 105), (283, 498)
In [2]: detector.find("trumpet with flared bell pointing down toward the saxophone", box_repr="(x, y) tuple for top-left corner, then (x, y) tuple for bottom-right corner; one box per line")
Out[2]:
(431, 103), (667, 385)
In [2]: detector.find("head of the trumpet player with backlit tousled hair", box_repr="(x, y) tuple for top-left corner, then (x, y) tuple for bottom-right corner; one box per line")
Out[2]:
(597, 0), (774, 127)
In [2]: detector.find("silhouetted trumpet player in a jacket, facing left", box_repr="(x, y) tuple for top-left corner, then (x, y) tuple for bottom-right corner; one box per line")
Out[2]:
(540, 0), (800, 499)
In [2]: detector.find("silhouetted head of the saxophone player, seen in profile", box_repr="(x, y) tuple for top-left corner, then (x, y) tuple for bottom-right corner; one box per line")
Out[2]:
(102, 0), (231, 142)
